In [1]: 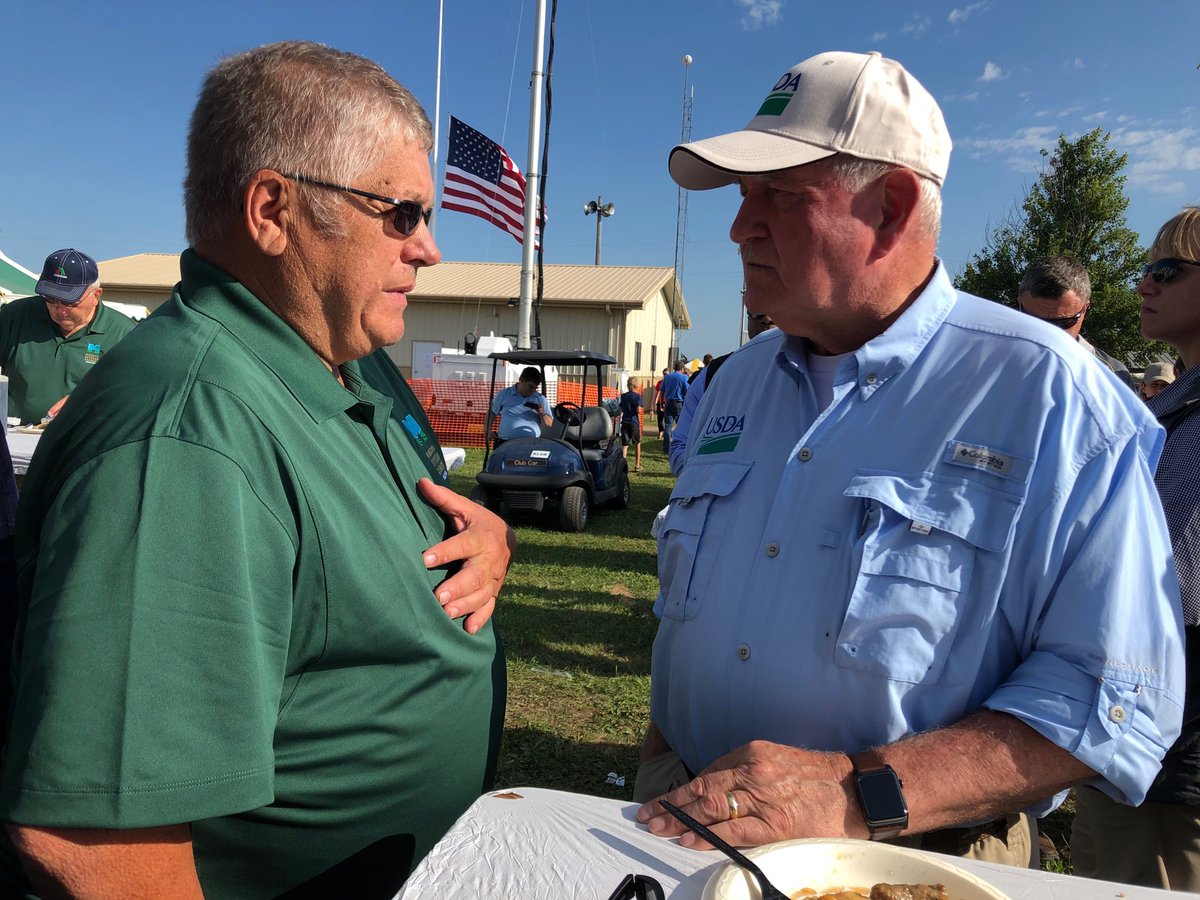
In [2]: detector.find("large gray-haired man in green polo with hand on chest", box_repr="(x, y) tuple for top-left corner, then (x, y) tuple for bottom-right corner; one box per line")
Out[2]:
(0, 42), (512, 900)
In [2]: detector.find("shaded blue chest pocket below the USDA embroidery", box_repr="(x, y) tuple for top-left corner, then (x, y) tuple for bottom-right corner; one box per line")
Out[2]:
(659, 462), (754, 620)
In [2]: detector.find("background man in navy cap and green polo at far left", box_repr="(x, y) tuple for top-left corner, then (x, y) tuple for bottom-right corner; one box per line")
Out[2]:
(0, 247), (136, 425)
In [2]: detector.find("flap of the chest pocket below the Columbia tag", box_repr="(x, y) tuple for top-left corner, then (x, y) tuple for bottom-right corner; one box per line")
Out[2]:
(844, 473), (1022, 551)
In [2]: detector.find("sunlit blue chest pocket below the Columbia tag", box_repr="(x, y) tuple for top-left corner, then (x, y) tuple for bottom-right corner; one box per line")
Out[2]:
(834, 473), (1021, 684)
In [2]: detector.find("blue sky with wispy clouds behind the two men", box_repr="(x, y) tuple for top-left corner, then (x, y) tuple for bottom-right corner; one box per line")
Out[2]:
(0, 0), (1200, 355)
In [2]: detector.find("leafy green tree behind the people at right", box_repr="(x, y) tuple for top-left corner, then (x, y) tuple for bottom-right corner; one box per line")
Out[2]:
(955, 128), (1169, 364)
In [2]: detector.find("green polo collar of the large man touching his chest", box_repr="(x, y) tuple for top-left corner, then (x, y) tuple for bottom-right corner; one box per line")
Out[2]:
(175, 250), (364, 424)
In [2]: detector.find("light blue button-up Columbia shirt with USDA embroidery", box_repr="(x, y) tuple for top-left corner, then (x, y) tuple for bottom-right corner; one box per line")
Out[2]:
(650, 265), (1183, 803)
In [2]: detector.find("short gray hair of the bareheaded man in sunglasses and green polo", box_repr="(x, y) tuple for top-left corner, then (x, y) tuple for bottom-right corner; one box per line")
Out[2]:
(184, 41), (433, 245)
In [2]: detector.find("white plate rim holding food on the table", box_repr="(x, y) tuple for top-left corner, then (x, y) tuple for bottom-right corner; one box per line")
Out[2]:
(703, 838), (1009, 900)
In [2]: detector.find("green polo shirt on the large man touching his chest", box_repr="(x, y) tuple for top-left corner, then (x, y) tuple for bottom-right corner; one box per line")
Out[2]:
(0, 252), (505, 900)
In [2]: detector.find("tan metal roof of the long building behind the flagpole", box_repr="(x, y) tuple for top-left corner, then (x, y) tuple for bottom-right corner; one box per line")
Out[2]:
(98, 253), (691, 328)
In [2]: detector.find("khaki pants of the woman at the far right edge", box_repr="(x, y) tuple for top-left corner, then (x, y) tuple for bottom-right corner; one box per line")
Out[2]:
(1070, 787), (1200, 892)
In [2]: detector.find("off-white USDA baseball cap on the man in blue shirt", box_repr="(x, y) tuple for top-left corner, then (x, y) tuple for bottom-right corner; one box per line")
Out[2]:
(668, 50), (950, 191)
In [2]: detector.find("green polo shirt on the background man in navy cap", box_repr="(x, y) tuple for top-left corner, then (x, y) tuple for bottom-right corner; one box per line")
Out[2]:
(0, 296), (137, 424)
